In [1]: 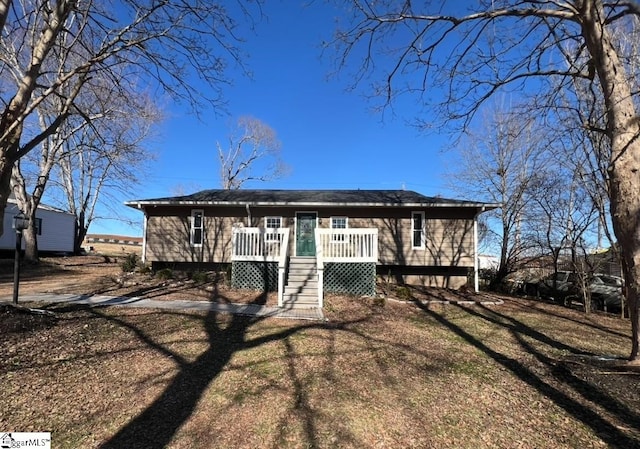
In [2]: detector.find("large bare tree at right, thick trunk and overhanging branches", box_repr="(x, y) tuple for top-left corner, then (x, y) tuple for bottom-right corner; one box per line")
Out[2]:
(335, 0), (640, 363)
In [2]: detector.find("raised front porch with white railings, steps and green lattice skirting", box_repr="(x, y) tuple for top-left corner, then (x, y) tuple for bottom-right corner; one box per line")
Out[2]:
(231, 228), (378, 308)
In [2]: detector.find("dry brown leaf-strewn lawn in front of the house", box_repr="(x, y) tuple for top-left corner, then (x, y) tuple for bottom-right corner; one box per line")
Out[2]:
(0, 254), (640, 449)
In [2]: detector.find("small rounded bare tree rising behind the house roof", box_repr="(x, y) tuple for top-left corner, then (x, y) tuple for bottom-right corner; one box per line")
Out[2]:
(216, 116), (289, 190)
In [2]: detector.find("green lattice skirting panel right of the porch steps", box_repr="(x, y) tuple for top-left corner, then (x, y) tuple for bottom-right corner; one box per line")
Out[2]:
(324, 262), (376, 296)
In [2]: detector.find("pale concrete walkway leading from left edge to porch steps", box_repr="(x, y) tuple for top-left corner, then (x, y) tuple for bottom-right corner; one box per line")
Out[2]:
(0, 293), (325, 321)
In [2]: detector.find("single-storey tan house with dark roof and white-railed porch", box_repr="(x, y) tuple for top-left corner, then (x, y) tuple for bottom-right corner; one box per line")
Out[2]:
(126, 190), (499, 307)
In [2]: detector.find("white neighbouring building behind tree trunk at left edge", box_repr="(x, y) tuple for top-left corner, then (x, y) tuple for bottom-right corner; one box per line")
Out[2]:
(0, 198), (76, 253)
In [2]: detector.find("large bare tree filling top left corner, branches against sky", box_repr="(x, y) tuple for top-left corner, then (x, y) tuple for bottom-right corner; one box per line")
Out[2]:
(0, 0), (261, 231)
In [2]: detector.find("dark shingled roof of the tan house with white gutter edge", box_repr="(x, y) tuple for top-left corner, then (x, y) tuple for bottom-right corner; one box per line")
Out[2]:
(125, 189), (498, 209)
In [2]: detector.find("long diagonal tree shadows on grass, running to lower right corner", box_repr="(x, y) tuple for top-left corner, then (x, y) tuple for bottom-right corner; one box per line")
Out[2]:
(419, 305), (640, 449)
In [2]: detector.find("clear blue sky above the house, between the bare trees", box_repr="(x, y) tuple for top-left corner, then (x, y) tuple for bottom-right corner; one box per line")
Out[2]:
(89, 1), (455, 235)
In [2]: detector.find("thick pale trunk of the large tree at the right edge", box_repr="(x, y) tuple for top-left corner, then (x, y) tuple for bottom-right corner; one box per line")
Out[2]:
(576, 0), (640, 363)
